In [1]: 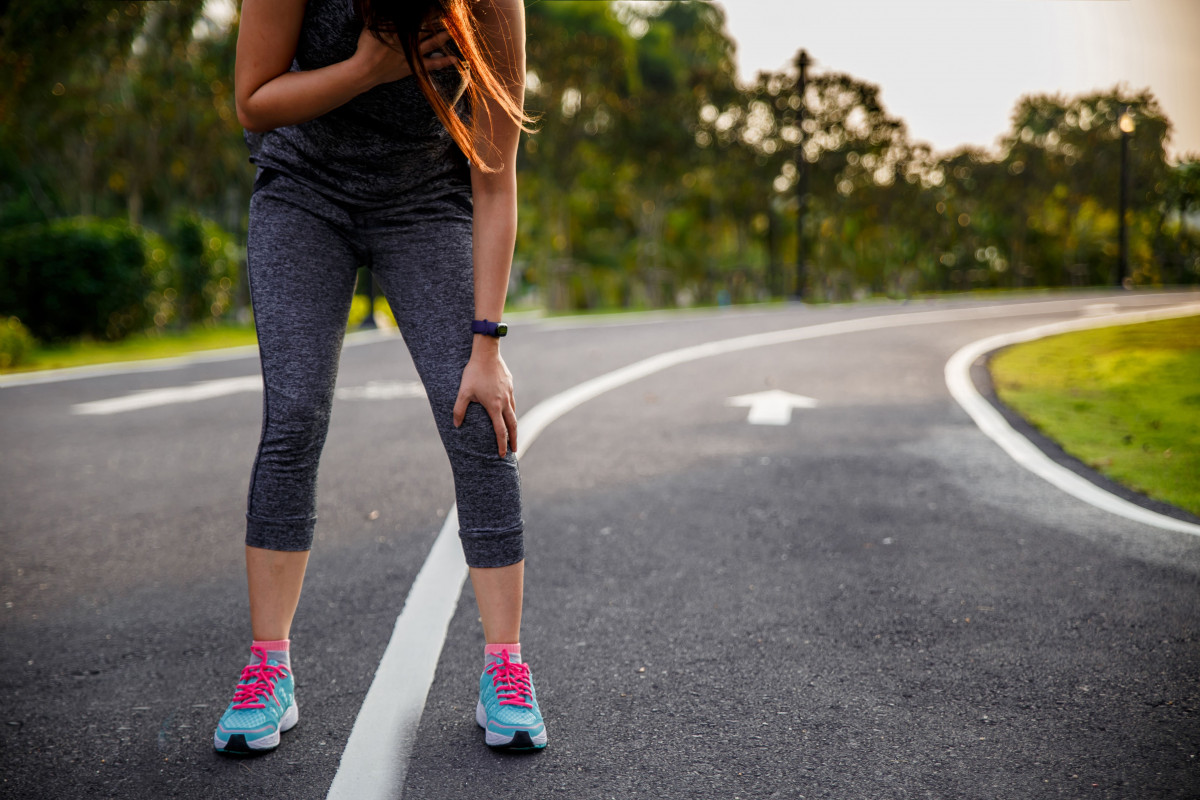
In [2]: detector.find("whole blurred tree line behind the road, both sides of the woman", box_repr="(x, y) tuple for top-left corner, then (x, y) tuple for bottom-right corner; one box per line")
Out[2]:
(0, 0), (1200, 347)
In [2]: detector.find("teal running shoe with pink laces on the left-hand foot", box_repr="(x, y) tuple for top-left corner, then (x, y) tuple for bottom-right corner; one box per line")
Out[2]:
(212, 646), (300, 754)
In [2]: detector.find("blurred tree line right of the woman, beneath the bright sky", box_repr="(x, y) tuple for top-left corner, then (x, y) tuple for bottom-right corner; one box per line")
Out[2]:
(517, 2), (1200, 308)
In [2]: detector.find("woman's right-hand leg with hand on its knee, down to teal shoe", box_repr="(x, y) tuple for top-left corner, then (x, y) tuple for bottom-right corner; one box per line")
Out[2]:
(370, 201), (546, 750)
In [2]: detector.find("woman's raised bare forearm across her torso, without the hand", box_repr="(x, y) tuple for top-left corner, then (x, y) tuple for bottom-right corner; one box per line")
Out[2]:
(238, 58), (373, 133)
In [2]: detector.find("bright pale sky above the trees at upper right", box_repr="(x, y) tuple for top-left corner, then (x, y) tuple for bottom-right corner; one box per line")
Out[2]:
(720, 0), (1200, 163)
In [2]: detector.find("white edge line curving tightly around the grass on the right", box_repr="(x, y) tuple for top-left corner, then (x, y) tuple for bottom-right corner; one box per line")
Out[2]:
(946, 303), (1200, 536)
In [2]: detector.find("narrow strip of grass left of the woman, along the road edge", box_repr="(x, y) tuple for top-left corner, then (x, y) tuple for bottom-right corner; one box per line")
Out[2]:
(0, 325), (258, 373)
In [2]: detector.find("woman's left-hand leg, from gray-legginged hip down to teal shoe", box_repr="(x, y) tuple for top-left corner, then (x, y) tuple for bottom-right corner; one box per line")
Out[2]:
(212, 173), (361, 753)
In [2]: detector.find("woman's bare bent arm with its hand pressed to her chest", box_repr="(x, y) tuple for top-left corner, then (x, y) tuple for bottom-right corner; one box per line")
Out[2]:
(234, 0), (455, 132)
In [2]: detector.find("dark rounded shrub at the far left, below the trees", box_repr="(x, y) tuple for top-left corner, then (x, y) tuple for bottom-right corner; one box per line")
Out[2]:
(0, 217), (164, 339)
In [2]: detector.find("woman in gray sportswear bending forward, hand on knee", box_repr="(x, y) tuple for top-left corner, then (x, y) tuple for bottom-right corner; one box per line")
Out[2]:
(214, 0), (546, 753)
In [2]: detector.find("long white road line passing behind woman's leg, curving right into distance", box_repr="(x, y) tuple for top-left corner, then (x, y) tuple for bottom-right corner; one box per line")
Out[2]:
(328, 295), (1200, 800)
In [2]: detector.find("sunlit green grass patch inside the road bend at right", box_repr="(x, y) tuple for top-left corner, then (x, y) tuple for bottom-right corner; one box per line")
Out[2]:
(990, 317), (1200, 515)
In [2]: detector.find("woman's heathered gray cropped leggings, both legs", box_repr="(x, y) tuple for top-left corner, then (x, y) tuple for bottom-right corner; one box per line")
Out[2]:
(246, 170), (524, 567)
